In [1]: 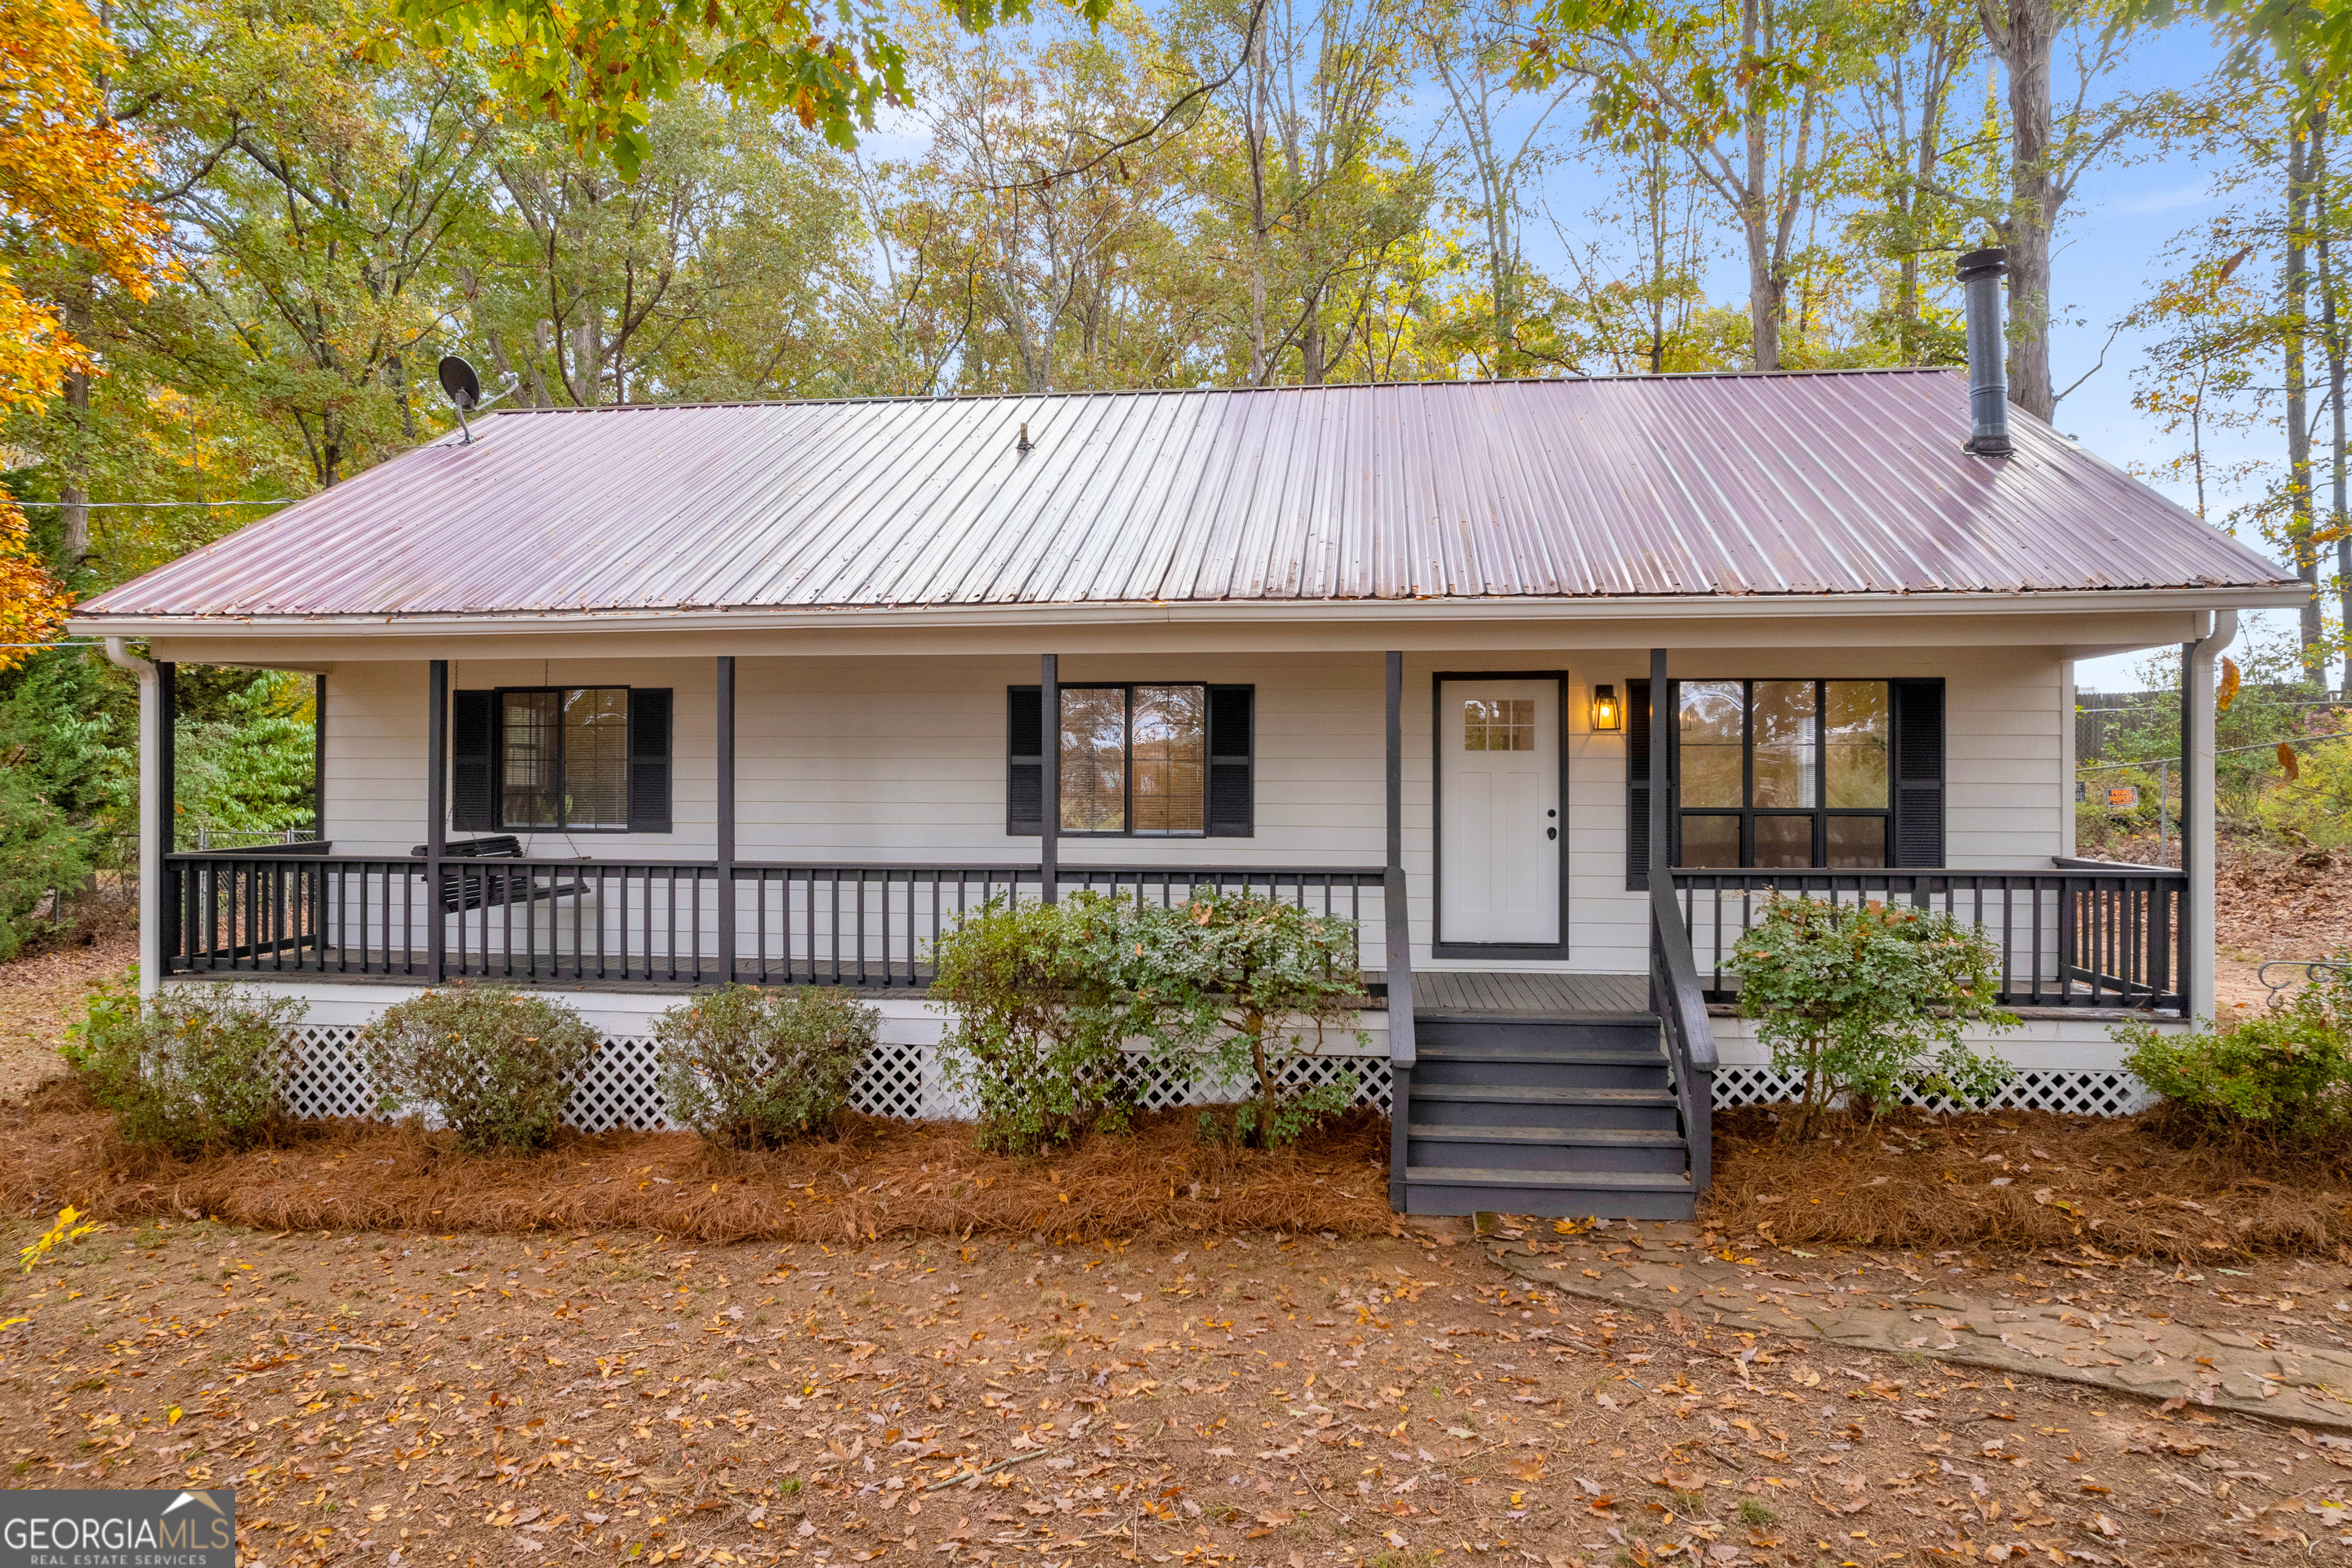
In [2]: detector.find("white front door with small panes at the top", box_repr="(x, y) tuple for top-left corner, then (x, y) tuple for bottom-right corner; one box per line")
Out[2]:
(1437, 679), (1561, 945)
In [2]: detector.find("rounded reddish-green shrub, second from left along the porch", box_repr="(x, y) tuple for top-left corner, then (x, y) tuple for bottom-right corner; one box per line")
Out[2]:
(360, 982), (602, 1154)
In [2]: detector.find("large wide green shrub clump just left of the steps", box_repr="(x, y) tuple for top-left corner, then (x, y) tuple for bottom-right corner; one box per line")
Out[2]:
(931, 889), (1362, 1147)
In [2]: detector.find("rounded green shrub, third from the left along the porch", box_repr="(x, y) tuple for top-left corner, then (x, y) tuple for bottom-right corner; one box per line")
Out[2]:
(654, 985), (882, 1150)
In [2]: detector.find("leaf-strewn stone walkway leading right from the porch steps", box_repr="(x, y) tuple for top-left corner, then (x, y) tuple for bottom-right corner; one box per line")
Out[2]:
(1484, 1225), (2352, 1432)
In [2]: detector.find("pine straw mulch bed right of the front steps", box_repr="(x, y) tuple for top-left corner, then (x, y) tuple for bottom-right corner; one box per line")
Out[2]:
(1698, 1107), (2352, 1263)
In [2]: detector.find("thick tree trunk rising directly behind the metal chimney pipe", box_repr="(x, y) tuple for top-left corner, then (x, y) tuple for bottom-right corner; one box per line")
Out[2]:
(1978, 0), (2058, 421)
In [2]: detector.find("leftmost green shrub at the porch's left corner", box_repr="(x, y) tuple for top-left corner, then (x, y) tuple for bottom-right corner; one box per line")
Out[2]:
(66, 969), (308, 1154)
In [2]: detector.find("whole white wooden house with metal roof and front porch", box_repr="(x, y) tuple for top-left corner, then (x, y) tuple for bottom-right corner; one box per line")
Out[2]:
(73, 282), (2305, 1215)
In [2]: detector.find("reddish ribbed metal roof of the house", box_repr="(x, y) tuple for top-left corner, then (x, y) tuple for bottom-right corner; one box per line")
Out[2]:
(80, 372), (2288, 628)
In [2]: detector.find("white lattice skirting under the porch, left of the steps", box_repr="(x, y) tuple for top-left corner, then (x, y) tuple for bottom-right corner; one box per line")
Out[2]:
(287, 1025), (1392, 1133)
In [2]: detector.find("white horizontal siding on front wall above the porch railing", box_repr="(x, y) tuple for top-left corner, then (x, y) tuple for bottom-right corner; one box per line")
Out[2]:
(327, 647), (2069, 973)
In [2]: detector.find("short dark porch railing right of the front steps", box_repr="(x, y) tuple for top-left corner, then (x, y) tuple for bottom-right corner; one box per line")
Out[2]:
(1673, 861), (2187, 1009)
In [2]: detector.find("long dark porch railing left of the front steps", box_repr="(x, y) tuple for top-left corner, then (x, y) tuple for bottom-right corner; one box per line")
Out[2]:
(165, 849), (1390, 990)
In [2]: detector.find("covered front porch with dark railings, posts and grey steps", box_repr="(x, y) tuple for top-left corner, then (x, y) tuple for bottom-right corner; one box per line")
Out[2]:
(114, 630), (2211, 1215)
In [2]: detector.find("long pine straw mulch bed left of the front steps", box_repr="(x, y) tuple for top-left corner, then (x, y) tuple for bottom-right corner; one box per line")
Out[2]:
(0, 1081), (1395, 1244)
